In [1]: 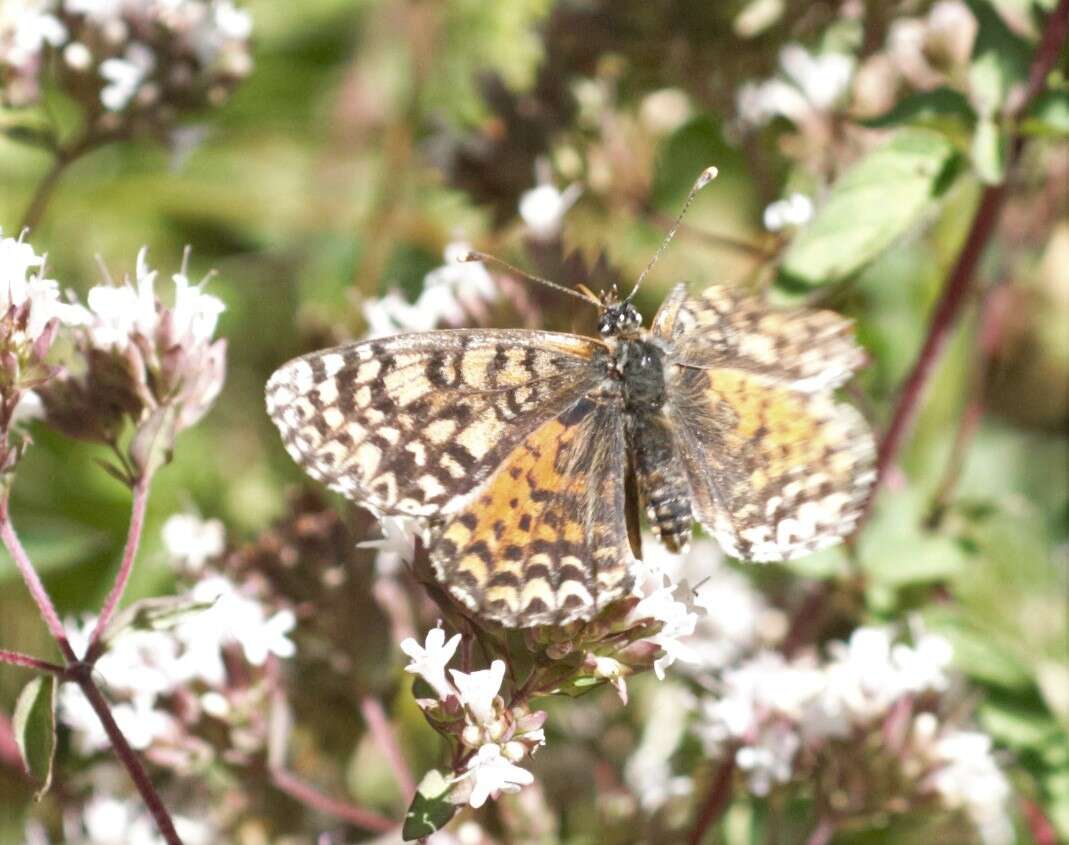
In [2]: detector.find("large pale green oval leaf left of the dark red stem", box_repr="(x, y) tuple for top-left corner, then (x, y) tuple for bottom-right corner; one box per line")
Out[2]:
(780, 128), (958, 288)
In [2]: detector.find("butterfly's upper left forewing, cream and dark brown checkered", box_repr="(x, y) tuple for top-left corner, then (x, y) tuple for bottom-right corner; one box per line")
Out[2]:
(266, 329), (601, 517)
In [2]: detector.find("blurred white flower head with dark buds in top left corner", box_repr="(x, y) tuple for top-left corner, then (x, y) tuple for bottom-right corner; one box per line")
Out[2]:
(0, 0), (252, 113)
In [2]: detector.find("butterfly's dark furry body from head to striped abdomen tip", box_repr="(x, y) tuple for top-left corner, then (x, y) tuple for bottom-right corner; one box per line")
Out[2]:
(598, 303), (694, 552)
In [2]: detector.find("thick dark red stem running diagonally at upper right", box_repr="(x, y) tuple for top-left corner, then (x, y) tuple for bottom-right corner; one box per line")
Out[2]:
(868, 0), (1069, 505)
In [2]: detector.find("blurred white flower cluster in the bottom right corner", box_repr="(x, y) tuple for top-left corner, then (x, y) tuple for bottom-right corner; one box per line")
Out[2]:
(698, 628), (1010, 845)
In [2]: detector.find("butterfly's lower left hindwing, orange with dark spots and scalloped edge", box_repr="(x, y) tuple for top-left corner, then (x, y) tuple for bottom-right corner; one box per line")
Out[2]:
(431, 399), (635, 627)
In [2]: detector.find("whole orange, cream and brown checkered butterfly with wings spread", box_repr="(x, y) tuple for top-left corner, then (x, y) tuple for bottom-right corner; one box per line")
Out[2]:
(266, 278), (876, 627)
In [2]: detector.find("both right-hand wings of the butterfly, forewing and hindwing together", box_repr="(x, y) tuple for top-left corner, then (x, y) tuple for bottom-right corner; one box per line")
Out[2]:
(653, 288), (874, 560)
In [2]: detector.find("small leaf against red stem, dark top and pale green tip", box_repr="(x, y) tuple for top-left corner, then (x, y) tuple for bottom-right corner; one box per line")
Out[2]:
(969, 0), (1032, 117)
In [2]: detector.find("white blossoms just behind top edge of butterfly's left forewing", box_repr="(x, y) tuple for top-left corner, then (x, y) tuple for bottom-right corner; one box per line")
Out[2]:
(363, 242), (498, 337)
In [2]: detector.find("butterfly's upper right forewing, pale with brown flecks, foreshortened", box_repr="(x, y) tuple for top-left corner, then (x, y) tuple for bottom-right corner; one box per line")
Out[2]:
(651, 285), (865, 394)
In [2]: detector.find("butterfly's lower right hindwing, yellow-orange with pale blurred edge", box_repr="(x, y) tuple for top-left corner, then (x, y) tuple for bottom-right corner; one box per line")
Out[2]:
(672, 367), (876, 560)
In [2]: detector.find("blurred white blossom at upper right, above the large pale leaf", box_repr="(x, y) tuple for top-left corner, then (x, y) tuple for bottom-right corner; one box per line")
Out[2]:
(735, 44), (854, 127)
